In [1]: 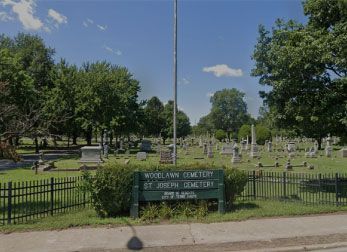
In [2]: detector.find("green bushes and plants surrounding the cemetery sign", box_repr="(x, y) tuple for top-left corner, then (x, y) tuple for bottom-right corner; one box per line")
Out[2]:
(83, 164), (247, 219)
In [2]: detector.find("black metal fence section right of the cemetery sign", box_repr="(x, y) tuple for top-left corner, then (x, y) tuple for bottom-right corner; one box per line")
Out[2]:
(241, 170), (347, 206)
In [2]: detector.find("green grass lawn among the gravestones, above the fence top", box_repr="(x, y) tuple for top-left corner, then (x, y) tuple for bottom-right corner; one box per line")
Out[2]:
(0, 144), (347, 182)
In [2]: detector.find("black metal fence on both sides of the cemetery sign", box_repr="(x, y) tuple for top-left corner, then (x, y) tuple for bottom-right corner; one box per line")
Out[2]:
(0, 170), (347, 225)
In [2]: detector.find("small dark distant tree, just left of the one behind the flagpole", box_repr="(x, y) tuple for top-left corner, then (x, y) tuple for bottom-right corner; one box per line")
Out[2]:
(144, 96), (165, 136)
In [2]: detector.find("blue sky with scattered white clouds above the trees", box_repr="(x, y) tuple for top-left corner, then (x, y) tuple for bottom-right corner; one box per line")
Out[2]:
(0, 0), (306, 125)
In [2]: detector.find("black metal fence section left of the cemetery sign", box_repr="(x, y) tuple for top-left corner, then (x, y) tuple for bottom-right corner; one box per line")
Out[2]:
(0, 177), (89, 225)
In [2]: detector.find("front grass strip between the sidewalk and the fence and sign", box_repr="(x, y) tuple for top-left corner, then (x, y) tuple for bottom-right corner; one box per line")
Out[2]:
(0, 201), (347, 232)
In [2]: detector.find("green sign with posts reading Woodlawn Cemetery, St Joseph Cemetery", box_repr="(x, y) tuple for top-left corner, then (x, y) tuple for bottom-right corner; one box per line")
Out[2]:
(130, 169), (225, 218)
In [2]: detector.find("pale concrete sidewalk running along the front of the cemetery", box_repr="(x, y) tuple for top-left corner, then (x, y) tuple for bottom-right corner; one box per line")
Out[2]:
(0, 214), (347, 252)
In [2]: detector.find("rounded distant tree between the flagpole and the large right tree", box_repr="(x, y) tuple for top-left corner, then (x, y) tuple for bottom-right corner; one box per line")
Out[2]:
(210, 88), (249, 138)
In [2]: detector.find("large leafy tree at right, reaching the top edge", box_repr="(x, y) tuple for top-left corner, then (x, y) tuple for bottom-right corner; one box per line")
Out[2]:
(252, 0), (347, 149)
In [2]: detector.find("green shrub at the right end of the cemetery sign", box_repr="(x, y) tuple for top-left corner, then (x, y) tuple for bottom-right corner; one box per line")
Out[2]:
(224, 168), (248, 208)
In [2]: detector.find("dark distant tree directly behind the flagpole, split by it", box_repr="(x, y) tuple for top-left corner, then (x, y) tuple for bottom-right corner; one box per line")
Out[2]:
(161, 101), (191, 143)
